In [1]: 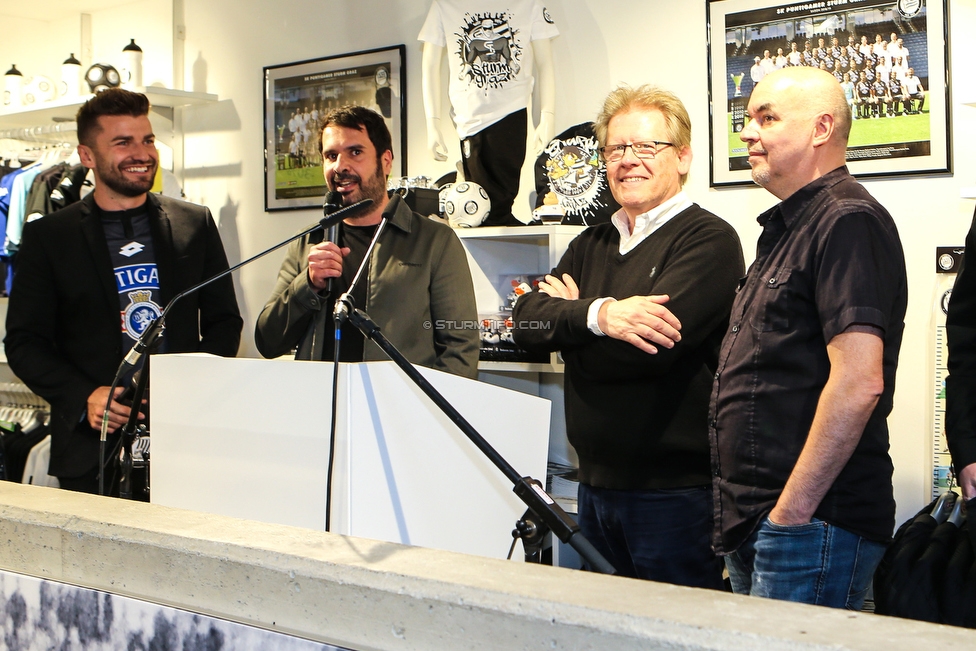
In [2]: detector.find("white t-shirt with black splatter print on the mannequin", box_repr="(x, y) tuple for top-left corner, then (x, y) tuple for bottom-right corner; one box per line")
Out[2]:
(417, 0), (559, 139)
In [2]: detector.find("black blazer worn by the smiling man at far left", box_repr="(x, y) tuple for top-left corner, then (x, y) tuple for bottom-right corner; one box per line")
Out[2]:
(4, 194), (243, 477)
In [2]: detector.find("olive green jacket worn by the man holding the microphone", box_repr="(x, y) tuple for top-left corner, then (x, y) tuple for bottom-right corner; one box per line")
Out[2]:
(254, 203), (480, 378)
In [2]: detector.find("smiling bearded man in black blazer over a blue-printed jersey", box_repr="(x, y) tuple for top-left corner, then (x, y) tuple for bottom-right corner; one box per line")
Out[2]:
(4, 89), (243, 492)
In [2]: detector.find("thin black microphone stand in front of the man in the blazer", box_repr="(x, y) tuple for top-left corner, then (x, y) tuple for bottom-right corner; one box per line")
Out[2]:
(98, 199), (373, 497)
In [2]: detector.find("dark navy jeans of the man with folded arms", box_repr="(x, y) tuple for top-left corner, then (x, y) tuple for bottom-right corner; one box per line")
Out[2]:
(579, 484), (724, 590)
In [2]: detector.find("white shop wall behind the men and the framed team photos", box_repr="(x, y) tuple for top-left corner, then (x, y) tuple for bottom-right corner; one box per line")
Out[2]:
(0, 0), (976, 521)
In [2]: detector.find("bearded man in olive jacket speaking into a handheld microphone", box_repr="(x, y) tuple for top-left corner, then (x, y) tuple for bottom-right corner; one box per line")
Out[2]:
(255, 106), (479, 378)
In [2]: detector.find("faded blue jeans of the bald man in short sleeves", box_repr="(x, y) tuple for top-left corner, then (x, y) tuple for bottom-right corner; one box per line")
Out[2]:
(725, 517), (886, 610)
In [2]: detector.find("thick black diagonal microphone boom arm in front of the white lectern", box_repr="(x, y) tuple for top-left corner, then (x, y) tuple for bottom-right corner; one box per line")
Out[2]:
(340, 308), (616, 574)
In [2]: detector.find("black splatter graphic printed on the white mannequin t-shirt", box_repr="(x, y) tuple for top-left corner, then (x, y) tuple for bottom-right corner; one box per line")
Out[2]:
(454, 12), (522, 89)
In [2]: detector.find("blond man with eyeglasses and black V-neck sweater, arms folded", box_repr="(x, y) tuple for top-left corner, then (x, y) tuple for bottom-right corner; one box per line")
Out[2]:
(513, 86), (743, 589)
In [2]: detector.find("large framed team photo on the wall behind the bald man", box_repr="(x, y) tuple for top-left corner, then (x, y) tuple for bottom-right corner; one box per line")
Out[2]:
(707, 0), (952, 187)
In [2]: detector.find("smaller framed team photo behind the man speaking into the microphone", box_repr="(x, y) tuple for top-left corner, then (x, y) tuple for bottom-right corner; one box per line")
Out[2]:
(264, 45), (407, 211)
